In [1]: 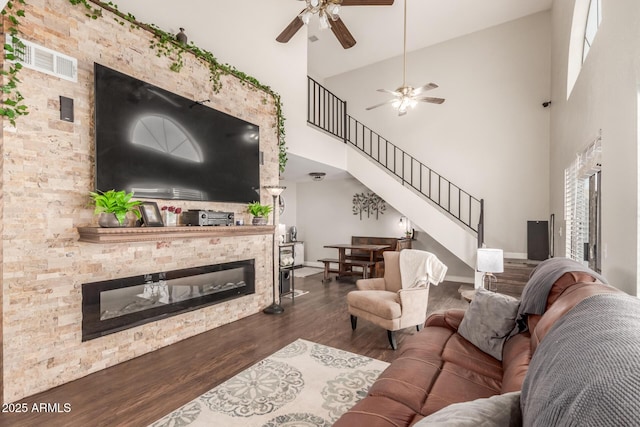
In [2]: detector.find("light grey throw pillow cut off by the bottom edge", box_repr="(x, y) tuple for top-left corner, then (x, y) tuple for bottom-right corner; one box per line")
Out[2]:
(414, 391), (522, 427)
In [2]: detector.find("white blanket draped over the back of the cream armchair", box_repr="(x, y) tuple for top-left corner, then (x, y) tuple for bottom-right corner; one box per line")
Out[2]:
(400, 249), (447, 289)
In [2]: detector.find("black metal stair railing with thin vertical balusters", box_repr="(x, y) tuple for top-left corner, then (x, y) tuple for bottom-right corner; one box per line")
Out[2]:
(307, 77), (484, 241)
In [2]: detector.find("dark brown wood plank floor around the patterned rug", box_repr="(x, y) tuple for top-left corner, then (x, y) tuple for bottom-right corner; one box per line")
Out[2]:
(0, 274), (466, 427)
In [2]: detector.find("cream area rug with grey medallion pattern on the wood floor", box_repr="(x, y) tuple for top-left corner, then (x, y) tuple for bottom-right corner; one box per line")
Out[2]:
(152, 339), (389, 427)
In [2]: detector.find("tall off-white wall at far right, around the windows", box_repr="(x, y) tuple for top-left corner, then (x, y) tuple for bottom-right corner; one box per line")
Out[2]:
(550, 0), (640, 295)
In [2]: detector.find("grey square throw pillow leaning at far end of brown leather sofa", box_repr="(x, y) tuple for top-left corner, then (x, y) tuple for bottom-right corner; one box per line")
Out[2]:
(458, 288), (520, 360)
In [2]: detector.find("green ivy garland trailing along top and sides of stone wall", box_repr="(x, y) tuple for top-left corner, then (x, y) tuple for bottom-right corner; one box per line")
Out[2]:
(0, 0), (287, 172)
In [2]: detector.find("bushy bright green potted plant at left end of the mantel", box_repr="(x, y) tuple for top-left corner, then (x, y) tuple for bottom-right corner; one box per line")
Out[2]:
(89, 190), (142, 227)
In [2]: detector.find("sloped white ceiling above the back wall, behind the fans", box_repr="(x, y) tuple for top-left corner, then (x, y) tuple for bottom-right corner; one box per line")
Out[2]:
(304, 0), (553, 78)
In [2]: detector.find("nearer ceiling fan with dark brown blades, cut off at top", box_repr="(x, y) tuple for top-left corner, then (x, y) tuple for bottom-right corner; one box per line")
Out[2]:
(276, 0), (394, 49)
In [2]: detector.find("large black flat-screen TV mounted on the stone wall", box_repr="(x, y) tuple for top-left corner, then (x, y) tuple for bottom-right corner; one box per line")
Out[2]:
(94, 64), (260, 203)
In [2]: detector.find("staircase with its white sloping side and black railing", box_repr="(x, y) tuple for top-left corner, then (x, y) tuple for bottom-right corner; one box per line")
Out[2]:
(307, 78), (484, 269)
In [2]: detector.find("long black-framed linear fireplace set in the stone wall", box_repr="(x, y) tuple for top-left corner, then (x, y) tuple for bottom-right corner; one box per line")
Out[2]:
(82, 259), (255, 341)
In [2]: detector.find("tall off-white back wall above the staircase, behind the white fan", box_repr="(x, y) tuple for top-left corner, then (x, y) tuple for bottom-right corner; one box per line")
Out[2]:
(325, 12), (551, 256)
